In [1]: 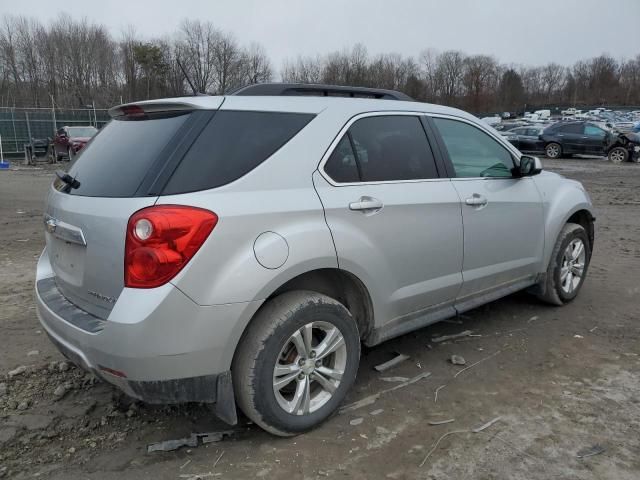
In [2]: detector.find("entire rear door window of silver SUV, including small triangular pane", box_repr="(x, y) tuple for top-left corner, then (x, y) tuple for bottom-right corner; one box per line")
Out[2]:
(325, 115), (438, 182)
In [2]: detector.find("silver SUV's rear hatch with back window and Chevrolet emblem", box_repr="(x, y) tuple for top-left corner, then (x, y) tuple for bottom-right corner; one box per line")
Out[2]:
(44, 97), (222, 319)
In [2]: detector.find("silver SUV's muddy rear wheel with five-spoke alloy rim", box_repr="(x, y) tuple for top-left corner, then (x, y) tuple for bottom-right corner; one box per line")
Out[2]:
(231, 291), (360, 437)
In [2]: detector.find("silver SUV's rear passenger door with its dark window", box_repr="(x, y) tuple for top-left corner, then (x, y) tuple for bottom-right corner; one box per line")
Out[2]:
(314, 113), (462, 326)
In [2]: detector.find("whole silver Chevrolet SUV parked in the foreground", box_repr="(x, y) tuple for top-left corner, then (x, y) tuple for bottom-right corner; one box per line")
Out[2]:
(36, 84), (594, 435)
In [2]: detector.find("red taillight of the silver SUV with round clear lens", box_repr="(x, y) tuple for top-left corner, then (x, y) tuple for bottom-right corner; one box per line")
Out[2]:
(124, 205), (218, 288)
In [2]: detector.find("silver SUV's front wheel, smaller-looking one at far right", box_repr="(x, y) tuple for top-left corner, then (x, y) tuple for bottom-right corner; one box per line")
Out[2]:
(538, 223), (591, 305)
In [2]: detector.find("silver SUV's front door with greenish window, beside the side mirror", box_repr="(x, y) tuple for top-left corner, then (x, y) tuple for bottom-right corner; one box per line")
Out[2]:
(433, 117), (544, 310)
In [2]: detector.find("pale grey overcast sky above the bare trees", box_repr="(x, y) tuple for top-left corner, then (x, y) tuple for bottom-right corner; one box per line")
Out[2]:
(0, 0), (640, 69)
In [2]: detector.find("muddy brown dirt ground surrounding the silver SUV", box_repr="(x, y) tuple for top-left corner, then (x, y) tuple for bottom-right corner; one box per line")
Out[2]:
(0, 159), (640, 480)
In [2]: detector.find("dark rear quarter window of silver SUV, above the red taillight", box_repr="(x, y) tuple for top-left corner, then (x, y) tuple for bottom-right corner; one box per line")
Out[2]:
(163, 111), (314, 195)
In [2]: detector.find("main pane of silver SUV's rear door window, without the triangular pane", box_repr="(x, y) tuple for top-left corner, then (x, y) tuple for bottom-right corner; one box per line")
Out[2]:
(349, 115), (438, 182)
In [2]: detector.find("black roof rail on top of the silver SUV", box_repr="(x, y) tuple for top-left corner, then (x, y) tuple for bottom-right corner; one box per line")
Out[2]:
(229, 83), (414, 102)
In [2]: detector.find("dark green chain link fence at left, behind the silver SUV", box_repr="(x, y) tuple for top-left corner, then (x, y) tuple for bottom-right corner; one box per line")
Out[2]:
(0, 107), (110, 158)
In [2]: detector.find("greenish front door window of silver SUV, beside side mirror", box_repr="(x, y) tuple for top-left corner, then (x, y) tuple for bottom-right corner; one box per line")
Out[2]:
(433, 118), (514, 177)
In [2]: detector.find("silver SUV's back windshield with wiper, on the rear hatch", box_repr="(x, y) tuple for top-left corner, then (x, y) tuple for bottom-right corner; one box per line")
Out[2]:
(63, 114), (189, 197)
